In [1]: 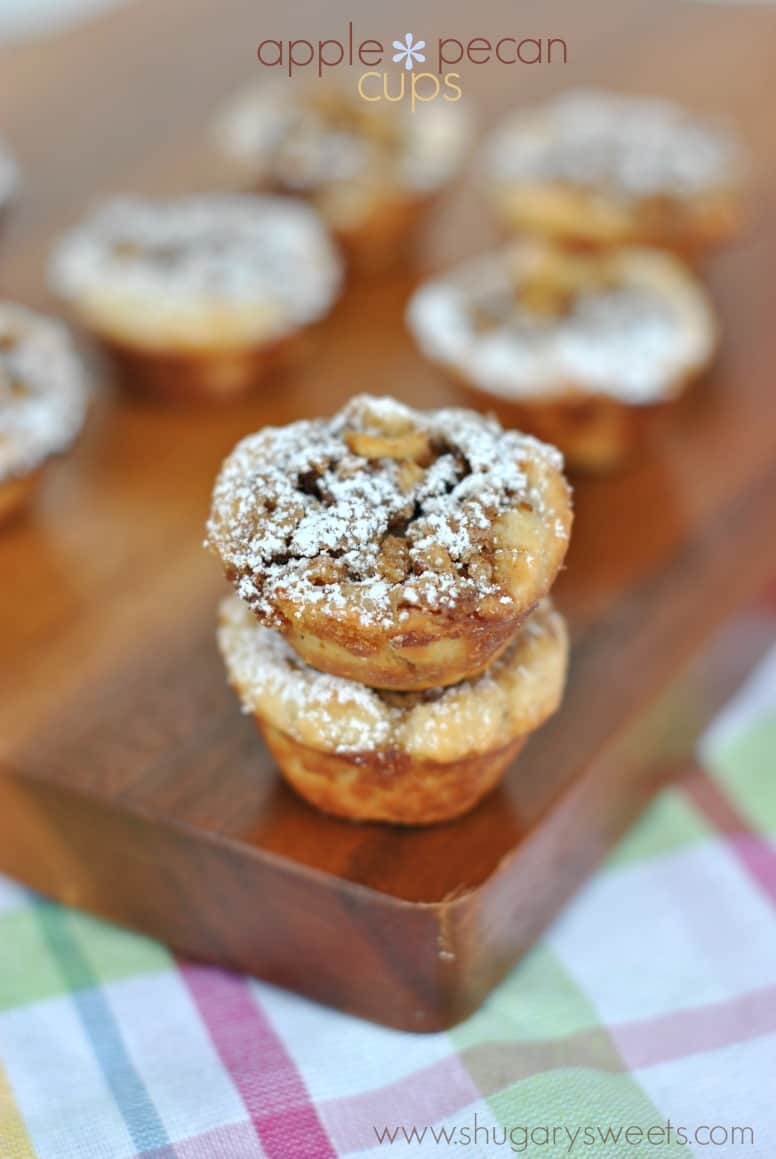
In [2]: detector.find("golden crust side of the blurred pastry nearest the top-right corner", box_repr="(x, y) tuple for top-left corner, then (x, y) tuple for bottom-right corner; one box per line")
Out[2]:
(486, 181), (745, 262)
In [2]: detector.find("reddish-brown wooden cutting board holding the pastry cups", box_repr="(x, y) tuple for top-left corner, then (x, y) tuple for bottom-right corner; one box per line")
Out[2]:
(0, 0), (776, 1030)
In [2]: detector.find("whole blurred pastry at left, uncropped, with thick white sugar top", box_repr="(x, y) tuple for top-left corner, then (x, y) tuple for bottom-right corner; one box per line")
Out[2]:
(50, 196), (342, 400)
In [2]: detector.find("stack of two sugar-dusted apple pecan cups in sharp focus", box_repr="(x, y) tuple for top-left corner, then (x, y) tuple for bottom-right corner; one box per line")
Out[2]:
(208, 395), (571, 825)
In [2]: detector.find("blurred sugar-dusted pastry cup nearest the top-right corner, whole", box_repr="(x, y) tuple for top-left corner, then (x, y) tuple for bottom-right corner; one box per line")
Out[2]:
(483, 89), (746, 257)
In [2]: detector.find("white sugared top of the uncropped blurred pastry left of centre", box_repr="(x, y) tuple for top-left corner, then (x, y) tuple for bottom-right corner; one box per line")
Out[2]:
(51, 195), (342, 333)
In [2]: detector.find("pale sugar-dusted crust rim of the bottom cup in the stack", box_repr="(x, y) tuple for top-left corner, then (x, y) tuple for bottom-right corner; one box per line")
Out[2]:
(218, 596), (568, 759)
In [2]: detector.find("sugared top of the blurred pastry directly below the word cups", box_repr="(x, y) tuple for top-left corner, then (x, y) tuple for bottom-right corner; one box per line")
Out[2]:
(217, 85), (469, 210)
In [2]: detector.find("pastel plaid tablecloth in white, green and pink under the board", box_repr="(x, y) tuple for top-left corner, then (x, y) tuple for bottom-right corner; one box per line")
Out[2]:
(0, 651), (776, 1159)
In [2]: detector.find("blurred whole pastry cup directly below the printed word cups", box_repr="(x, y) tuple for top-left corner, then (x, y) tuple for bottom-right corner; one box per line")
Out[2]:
(215, 82), (470, 271)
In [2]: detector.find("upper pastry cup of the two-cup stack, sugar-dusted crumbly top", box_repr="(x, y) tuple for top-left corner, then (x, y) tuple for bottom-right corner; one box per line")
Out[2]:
(207, 395), (571, 691)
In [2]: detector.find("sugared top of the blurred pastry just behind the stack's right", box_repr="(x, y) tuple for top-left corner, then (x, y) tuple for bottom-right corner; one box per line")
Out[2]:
(408, 241), (715, 404)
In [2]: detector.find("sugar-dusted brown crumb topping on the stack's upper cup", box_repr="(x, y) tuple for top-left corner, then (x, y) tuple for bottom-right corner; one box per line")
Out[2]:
(207, 395), (568, 627)
